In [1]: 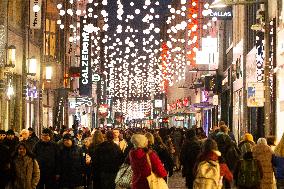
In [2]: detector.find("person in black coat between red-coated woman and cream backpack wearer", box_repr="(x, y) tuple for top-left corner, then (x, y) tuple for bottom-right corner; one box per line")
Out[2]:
(180, 129), (201, 188)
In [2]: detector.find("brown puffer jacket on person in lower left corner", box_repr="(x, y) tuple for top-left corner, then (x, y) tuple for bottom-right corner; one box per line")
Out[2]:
(12, 155), (40, 189)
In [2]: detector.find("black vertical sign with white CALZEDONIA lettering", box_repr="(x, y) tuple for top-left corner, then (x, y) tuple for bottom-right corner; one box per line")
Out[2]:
(79, 17), (92, 97)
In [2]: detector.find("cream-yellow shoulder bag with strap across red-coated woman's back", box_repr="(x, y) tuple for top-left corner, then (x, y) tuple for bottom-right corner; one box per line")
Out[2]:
(146, 153), (169, 189)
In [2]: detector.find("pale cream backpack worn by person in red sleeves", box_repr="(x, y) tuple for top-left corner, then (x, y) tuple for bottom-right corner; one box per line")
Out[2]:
(193, 160), (222, 189)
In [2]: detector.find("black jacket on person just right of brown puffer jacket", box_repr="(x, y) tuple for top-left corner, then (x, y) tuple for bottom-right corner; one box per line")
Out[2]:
(33, 141), (60, 183)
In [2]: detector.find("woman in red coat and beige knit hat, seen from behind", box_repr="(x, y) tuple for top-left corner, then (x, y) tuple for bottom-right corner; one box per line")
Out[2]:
(129, 134), (167, 189)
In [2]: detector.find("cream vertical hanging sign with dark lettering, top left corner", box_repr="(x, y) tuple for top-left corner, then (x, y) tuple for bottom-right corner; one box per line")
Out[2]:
(30, 0), (42, 29)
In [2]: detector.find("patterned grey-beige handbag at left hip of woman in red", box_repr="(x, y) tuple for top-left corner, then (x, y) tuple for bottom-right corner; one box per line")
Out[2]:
(115, 163), (133, 188)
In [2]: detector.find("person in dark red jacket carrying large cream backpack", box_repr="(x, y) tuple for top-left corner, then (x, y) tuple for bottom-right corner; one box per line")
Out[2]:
(193, 139), (233, 189)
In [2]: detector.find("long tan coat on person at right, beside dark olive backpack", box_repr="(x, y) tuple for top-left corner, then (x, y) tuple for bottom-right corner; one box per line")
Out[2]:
(252, 144), (273, 189)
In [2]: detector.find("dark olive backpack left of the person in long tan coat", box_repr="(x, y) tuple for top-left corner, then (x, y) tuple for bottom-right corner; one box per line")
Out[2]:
(237, 159), (261, 187)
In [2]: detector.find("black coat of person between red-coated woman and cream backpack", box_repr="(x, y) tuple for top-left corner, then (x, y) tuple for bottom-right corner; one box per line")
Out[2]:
(180, 137), (201, 181)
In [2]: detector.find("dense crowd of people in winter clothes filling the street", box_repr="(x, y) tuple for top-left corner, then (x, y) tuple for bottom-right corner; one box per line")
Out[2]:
(0, 122), (284, 189)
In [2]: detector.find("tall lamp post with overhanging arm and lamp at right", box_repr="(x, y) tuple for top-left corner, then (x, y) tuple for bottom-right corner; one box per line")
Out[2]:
(210, 0), (271, 136)
